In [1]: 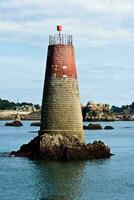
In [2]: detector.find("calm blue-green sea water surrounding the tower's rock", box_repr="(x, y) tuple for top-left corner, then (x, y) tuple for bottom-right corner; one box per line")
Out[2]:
(0, 121), (134, 200)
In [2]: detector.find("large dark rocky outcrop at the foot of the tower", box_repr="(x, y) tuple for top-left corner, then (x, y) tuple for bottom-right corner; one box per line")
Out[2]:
(10, 134), (111, 161)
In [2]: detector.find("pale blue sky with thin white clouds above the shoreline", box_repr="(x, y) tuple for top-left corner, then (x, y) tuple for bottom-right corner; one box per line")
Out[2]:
(0, 0), (134, 106)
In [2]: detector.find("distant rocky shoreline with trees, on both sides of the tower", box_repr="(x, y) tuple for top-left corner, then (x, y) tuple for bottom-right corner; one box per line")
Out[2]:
(0, 99), (134, 122)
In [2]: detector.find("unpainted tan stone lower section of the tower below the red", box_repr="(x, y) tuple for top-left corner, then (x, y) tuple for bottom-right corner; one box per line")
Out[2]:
(40, 77), (84, 141)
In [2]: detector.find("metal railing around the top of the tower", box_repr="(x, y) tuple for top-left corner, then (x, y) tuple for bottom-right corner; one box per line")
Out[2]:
(49, 34), (73, 45)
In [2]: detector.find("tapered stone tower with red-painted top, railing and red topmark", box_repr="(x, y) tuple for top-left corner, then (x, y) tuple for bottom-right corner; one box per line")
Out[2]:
(39, 25), (84, 142)
